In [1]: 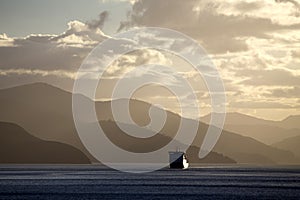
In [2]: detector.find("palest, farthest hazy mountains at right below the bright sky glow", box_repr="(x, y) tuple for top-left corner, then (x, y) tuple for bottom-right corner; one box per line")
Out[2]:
(200, 113), (300, 145)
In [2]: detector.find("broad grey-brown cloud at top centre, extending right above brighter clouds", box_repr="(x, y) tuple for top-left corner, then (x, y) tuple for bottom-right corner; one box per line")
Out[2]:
(120, 0), (300, 53)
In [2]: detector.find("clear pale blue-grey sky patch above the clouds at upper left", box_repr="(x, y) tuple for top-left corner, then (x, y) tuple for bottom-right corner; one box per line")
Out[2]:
(0, 0), (131, 37)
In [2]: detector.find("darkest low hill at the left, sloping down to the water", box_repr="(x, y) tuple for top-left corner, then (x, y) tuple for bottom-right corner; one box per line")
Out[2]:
(0, 122), (89, 164)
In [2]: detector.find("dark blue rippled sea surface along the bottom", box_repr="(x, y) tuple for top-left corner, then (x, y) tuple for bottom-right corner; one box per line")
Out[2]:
(0, 165), (300, 200)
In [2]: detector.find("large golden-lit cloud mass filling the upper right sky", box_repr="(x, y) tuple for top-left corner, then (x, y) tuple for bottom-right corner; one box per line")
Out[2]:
(114, 0), (300, 115)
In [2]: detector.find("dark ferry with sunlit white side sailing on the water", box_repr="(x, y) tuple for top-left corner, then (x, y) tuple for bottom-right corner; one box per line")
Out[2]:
(169, 151), (189, 169)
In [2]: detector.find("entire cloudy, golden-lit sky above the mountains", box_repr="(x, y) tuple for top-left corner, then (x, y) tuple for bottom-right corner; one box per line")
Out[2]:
(0, 0), (300, 120)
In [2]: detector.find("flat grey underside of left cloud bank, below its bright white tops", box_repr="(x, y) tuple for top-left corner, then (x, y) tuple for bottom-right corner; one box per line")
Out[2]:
(0, 36), (90, 69)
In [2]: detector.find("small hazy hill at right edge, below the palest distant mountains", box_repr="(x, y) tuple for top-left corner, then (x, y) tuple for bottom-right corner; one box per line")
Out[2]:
(272, 135), (300, 157)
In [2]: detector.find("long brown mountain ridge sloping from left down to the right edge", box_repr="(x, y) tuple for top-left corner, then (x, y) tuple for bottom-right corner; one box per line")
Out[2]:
(0, 84), (298, 164)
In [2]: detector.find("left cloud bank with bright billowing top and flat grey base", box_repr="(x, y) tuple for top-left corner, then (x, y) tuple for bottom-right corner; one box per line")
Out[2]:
(0, 21), (108, 70)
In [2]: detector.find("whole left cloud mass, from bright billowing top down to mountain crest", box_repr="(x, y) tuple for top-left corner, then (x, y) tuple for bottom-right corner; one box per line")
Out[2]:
(0, 15), (110, 90)
